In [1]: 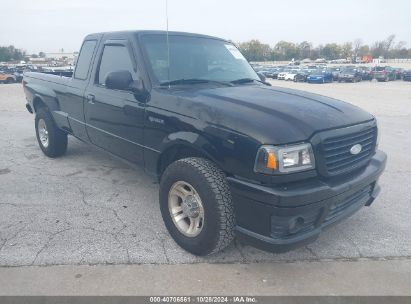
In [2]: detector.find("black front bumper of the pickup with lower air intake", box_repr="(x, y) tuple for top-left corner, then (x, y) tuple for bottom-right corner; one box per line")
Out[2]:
(228, 151), (387, 252)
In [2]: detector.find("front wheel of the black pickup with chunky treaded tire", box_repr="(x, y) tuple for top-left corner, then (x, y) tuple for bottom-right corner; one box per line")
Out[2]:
(160, 157), (235, 256)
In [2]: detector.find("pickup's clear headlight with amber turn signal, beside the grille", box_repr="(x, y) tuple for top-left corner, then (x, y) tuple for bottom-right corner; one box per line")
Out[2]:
(254, 144), (315, 174)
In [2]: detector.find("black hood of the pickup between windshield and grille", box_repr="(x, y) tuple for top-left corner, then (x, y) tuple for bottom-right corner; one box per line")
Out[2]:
(180, 85), (374, 144)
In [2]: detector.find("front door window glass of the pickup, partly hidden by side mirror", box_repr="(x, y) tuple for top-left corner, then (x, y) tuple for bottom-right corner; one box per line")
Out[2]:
(97, 45), (133, 86)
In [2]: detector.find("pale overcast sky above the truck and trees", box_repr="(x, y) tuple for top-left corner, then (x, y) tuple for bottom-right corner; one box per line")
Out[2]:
(0, 0), (411, 53)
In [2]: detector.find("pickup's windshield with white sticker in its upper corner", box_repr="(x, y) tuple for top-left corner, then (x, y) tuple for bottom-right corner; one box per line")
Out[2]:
(141, 34), (260, 83)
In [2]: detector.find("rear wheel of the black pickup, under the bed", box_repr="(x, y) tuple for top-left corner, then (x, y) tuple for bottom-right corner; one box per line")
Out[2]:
(35, 108), (67, 158)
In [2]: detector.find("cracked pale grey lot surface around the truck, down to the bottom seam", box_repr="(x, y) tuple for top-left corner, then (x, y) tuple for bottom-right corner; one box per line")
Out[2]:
(0, 81), (411, 266)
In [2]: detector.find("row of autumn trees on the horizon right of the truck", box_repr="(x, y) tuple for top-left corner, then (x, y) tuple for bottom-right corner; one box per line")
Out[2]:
(238, 35), (411, 61)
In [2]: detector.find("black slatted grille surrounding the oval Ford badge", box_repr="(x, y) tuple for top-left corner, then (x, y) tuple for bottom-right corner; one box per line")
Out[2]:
(322, 127), (377, 175)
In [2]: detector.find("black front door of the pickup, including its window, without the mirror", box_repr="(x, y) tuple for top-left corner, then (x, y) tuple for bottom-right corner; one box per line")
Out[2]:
(84, 40), (145, 163)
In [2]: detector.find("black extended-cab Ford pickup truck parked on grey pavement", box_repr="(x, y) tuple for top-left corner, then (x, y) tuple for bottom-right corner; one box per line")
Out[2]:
(23, 31), (386, 255)
